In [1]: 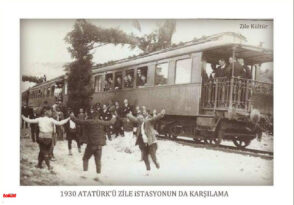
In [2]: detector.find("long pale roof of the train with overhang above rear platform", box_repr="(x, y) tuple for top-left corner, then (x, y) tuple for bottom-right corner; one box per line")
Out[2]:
(24, 32), (273, 90)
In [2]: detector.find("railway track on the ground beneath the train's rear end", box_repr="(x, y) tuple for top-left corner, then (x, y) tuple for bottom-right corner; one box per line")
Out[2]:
(158, 136), (273, 160)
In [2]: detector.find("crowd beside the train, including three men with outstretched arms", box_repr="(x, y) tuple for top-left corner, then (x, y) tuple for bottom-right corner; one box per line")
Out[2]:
(22, 99), (165, 179)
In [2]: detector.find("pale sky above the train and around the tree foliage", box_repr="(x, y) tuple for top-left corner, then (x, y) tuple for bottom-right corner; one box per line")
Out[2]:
(20, 19), (273, 91)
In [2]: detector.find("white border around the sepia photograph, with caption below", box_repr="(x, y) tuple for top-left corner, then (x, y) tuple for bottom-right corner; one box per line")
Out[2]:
(0, 0), (293, 205)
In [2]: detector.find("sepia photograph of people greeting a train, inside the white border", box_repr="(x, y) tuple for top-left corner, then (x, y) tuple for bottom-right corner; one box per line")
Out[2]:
(19, 19), (274, 186)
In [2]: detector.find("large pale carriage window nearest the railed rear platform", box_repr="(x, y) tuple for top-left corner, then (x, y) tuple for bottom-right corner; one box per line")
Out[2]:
(175, 59), (192, 84)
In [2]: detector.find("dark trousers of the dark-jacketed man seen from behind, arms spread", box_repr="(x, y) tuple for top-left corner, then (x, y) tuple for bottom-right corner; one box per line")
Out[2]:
(83, 144), (102, 174)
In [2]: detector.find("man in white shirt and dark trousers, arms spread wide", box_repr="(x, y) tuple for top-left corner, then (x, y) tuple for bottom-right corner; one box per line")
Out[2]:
(22, 108), (69, 170)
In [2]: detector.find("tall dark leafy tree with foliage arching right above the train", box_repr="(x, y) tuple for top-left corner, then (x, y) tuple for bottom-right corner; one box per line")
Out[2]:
(65, 19), (176, 111)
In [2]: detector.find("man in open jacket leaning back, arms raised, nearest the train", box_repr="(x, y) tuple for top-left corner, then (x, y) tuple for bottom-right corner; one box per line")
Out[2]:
(127, 110), (165, 176)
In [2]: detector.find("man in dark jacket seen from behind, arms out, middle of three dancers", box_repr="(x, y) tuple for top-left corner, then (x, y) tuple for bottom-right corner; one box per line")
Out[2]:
(70, 114), (116, 181)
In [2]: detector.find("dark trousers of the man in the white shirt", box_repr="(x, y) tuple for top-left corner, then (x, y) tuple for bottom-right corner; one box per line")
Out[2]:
(38, 138), (52, 169)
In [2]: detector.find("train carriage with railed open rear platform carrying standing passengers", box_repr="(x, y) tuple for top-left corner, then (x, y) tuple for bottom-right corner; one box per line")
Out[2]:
(23, 33), (273, 148)
